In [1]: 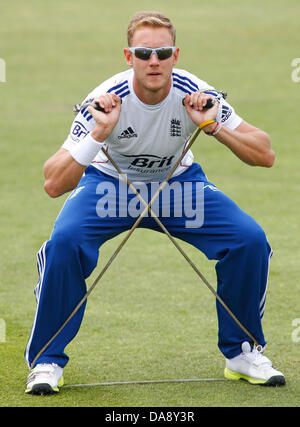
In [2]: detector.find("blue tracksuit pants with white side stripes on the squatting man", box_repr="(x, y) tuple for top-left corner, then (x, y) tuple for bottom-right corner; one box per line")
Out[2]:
(25, 163), (272, 367)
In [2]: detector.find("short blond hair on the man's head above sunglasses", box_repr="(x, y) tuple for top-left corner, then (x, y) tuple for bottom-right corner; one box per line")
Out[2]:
(127, 11), (176, 47)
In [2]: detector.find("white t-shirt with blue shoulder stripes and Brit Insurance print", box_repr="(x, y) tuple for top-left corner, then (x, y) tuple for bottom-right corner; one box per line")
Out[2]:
(62, 68), (242, 182)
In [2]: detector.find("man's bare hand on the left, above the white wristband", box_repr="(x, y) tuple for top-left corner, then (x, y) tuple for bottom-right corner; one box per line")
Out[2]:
(88, 93), (121, 142)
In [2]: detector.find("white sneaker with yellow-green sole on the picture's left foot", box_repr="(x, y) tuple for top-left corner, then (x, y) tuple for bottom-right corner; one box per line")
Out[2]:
(25, 363), (64, 395)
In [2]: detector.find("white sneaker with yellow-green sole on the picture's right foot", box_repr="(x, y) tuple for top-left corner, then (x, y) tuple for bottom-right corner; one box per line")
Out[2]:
(224, 342), (285, 386)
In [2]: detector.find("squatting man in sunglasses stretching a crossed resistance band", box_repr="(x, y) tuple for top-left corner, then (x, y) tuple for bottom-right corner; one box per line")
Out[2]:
(25, 12), (285, 394)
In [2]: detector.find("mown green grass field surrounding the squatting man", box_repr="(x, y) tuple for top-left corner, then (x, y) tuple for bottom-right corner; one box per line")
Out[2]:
(0, 0), (300, 407)
